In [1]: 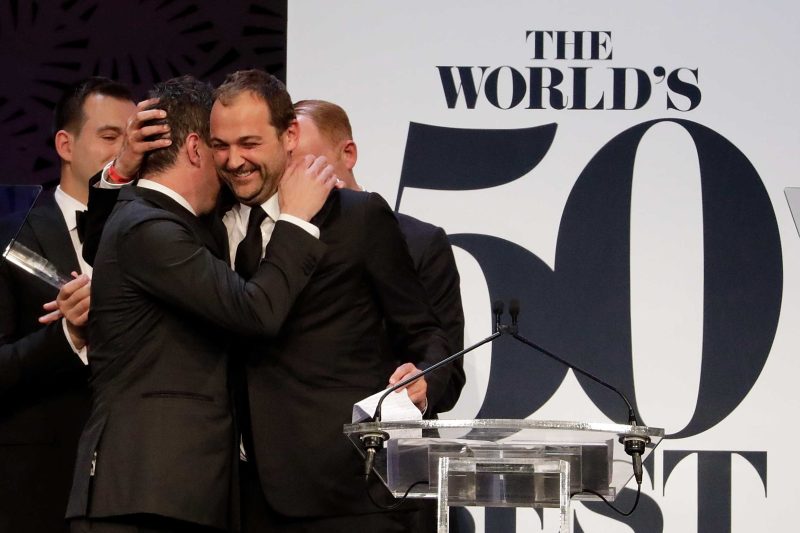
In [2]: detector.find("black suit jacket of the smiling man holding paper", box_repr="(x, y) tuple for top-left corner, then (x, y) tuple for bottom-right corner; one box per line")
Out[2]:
(247, 190), (450, 516)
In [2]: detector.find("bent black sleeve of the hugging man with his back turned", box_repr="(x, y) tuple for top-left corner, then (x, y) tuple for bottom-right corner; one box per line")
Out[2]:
(118, 219), (325, 336)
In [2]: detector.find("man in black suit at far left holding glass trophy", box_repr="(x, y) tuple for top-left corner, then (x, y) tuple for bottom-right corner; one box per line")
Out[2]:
(0, 78), (134, 533)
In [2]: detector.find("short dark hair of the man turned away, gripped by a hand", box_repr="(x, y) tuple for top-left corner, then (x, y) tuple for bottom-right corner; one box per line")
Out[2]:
(140, 75), (214, 174)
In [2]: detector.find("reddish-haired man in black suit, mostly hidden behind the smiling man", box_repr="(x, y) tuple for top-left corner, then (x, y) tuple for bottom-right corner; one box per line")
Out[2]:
(294, 100), (466, 417)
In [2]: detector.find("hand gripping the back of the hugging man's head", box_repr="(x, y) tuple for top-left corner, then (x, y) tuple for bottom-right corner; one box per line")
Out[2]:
(114, 98), (172, 179)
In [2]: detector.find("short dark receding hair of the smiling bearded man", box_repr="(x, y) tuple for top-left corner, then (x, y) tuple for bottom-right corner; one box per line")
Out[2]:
(214, 69), (295, 135)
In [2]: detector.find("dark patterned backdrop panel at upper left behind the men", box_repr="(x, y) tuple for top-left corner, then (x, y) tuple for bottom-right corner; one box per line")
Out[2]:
(0, 0), (286, 185)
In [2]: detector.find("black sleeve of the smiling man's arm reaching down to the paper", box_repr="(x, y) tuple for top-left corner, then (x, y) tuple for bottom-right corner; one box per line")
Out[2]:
(362, 193), (451, 405)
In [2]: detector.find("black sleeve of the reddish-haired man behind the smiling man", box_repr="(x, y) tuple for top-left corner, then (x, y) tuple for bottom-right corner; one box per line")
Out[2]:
(417, 228), (467, 414)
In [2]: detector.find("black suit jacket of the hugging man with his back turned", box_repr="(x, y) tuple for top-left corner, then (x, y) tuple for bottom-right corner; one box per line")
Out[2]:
(68, 187), (325, 528)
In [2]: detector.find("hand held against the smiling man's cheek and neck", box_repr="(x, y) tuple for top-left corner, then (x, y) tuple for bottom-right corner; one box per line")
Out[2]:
(278, 155), (343, 222)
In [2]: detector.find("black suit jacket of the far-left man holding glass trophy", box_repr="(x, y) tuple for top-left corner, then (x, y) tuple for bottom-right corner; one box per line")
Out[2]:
(0, 195), (89, 533)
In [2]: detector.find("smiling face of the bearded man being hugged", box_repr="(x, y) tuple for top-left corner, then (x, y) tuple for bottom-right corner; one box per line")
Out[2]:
(211, 91), (297, 205)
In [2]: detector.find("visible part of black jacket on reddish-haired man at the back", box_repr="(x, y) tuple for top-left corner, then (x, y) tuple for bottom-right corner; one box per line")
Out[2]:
(396, 213), (467, 417)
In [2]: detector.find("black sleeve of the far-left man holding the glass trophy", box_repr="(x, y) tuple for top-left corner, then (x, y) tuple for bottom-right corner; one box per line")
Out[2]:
(0, 261), (80, 397)
